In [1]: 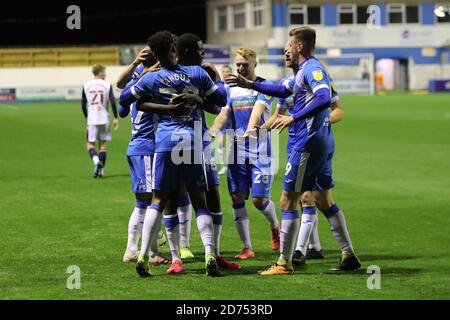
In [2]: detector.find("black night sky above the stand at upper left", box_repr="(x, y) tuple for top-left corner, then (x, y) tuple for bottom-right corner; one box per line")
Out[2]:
(0, 0), (206, 47)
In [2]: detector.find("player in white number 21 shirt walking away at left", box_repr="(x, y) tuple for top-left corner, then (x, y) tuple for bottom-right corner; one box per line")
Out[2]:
(81, 65), (119, 178)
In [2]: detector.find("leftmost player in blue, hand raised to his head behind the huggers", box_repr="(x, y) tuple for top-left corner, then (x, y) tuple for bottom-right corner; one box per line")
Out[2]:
(116, 46), (171, 264)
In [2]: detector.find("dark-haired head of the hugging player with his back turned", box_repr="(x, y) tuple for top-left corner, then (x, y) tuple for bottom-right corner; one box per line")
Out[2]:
(147, 31), (177, 67)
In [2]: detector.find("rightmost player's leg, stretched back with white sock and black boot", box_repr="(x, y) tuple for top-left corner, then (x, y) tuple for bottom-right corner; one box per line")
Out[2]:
(316, 188), (361, 270)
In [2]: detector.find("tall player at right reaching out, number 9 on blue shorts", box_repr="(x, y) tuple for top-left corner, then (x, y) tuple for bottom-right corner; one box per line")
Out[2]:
(229, 27), (360, 275)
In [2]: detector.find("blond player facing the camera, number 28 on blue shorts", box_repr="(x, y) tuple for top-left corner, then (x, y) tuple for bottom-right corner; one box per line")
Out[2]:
(213, 48), (280, 260)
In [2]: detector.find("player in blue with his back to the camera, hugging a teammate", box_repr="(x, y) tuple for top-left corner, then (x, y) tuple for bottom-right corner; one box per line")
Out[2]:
(120, 31), (226, 276)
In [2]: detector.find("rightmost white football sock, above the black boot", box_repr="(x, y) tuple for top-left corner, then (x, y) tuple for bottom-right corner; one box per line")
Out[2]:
(324, 204), (353, 254)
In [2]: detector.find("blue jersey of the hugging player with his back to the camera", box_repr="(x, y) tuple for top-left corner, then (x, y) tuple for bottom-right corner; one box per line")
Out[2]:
(131, 65), (221, 152)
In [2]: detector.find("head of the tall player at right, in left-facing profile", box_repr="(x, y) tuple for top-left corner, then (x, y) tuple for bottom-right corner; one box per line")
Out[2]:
(288, 26), (316, 61)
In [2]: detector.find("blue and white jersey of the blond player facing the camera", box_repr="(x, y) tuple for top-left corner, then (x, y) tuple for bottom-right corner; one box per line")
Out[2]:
(227, 78), (273, 159)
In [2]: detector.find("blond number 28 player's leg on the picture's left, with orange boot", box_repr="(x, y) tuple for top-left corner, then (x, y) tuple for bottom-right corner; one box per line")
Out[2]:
(227, 164), (255, 260)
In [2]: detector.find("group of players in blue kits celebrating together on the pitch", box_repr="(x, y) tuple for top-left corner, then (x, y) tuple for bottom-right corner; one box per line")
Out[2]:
(84, 27), (361, 277)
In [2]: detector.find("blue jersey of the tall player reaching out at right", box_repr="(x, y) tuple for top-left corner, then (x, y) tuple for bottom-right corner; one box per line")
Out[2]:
(284, 57), (334, 152)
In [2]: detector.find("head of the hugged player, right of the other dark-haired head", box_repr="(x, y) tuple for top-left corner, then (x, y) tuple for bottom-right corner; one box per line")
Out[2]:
(177, 33), (205, 66)
